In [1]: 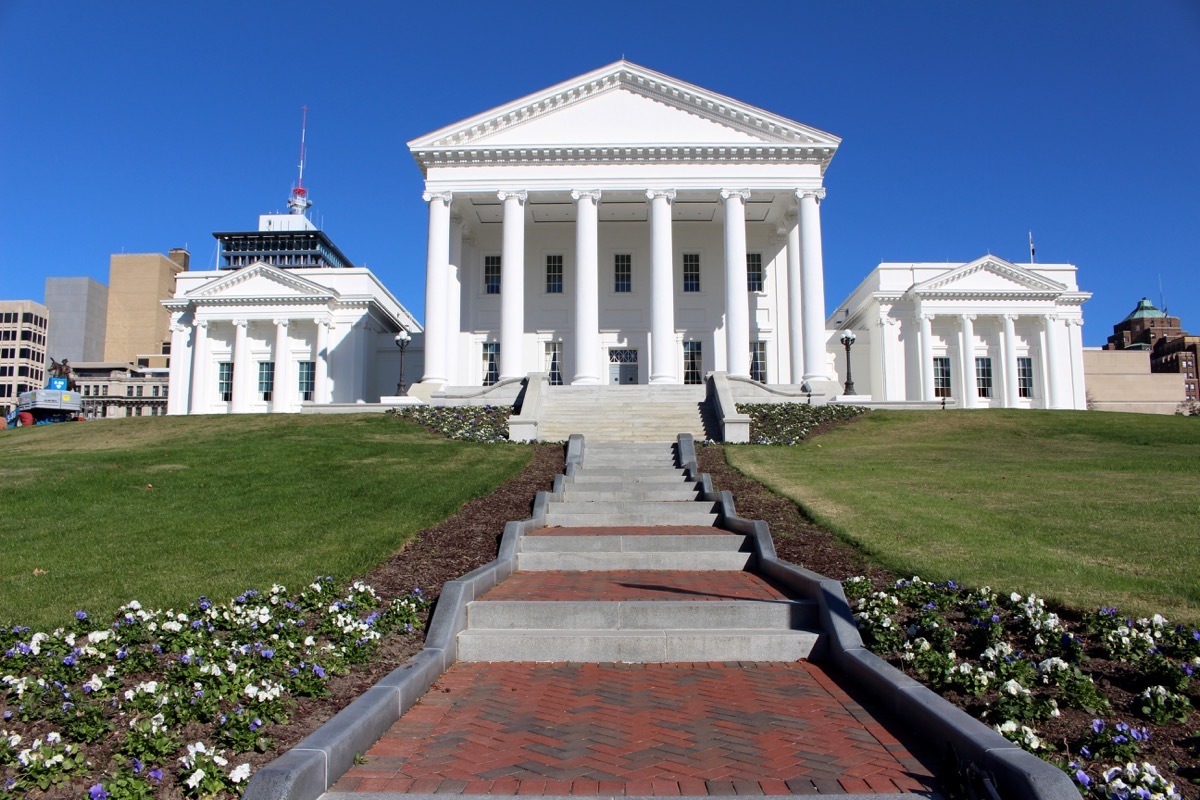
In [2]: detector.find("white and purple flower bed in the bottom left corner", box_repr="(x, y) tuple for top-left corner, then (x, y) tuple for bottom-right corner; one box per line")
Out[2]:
(0, 578), (427, 800)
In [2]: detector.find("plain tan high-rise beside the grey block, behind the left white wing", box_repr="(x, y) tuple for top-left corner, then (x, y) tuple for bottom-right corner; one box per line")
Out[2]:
(102, 248), (190, 368)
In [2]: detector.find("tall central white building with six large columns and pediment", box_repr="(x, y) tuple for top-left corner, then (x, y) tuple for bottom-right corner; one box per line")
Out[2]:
(409, 61), (840, 395)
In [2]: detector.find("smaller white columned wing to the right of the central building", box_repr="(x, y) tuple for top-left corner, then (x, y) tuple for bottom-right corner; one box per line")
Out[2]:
(828, 255), (1091, 409)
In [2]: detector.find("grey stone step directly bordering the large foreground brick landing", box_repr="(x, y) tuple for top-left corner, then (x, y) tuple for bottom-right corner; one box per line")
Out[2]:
(458, 623), (820, 663)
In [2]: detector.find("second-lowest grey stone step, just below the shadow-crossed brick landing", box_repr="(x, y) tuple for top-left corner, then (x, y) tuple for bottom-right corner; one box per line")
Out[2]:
(467, 600), (817, 631)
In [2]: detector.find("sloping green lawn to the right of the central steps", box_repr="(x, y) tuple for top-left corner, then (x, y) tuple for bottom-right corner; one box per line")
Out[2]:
(726, 411), (1200, 624)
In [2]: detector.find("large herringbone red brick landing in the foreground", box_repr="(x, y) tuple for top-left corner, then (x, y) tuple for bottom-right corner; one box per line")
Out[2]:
(332, 661), (935, 796)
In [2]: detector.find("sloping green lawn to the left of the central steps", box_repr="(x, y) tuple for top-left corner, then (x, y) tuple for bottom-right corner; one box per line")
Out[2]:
(0, 414), (530, 626)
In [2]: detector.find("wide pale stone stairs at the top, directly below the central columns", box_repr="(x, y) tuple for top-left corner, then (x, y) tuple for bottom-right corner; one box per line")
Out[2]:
(538, 385), (713, 444)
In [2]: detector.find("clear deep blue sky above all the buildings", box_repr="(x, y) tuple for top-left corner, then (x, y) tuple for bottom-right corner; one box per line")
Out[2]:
(0, 0), (1200, 345)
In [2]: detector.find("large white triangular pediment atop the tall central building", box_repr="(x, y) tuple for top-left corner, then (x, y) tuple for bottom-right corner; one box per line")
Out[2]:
(408, 61), (841, 167)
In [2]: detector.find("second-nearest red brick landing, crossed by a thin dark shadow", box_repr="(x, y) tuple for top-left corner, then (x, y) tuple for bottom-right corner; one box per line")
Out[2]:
(480, 570), (790, 601)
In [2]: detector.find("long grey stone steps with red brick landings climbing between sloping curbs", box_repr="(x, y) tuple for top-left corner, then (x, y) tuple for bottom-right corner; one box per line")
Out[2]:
(458, 444), (818, 662)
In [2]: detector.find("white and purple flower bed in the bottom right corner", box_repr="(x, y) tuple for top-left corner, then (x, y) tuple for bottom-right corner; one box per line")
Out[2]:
(842, 577), (1200, 798)
